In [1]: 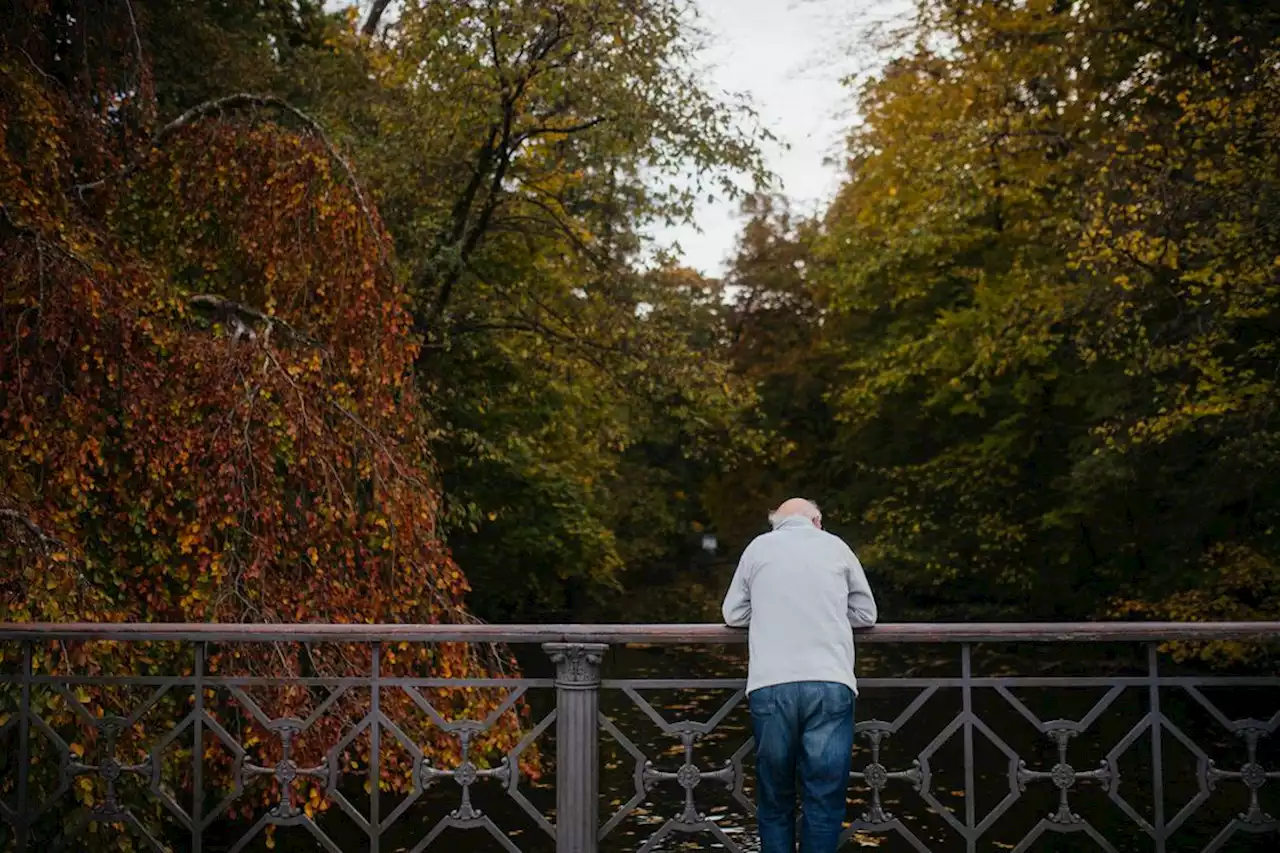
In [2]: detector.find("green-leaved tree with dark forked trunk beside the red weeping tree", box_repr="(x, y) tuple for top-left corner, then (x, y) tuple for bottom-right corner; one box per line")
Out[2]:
(325, 0), (762, 619)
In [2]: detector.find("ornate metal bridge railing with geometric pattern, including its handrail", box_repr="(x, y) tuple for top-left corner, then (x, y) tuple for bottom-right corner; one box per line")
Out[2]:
(0, 622), (1280, 853)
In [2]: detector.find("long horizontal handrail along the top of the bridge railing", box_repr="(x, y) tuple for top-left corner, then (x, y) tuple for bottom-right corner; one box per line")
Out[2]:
(0, 621), (1280, 637)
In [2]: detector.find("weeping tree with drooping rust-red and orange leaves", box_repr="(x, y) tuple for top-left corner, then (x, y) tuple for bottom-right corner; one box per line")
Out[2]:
(0, 0), (532, 835)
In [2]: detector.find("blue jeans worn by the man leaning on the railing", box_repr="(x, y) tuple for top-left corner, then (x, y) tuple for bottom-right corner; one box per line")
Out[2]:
(748, 681), (854, 853)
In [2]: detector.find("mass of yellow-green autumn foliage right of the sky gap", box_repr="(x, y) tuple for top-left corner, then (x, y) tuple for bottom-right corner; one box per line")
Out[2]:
(711, 0), (1280, 655)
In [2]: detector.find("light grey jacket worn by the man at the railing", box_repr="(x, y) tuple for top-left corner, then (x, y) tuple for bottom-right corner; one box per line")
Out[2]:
(722, 516), (877, 694)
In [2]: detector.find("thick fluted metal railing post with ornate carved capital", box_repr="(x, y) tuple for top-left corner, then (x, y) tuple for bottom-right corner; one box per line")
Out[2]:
(543, 643), (609, 853)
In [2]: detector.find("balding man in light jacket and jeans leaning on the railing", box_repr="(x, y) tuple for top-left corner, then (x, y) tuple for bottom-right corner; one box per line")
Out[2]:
(723, 498), (876, 853)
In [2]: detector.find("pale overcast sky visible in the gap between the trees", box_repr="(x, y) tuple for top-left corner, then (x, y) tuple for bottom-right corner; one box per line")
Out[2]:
(654, 0), (909, 275)
